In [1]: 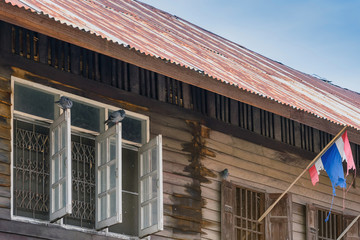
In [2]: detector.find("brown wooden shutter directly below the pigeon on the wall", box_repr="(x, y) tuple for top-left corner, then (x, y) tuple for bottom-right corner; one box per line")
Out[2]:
(221, 180), (235, 240)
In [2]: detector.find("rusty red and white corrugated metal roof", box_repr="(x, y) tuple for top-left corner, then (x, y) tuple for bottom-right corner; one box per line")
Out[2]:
(5, 0), (360, 130)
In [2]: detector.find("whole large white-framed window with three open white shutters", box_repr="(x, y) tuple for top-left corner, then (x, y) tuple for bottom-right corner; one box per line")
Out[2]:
(12, 78), (163, 236)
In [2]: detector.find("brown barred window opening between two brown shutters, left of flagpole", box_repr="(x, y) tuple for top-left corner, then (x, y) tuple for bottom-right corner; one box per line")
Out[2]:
(235, 187), (265, 240)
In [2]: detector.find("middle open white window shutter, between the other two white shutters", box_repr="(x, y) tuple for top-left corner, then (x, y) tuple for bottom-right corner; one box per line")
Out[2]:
(95, 123), (122, 230)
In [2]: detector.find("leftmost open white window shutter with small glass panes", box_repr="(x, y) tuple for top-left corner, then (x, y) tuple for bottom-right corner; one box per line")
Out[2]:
(50, 109), (72, 222)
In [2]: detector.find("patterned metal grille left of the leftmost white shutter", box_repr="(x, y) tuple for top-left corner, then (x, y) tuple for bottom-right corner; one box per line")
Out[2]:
(14, 120), (49, 220)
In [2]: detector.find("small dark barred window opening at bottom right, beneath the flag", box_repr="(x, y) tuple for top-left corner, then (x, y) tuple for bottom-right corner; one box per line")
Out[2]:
(317, 209), (343, 240)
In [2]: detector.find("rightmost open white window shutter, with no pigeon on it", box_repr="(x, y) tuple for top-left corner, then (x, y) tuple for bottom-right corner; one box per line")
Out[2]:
(139, 135), (164, 237)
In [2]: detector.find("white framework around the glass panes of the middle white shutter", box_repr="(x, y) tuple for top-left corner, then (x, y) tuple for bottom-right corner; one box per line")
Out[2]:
(95, 123), (122, 230)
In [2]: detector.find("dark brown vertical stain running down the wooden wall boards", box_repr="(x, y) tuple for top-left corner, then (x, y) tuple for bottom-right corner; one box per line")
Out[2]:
(163, 121), (216, 236)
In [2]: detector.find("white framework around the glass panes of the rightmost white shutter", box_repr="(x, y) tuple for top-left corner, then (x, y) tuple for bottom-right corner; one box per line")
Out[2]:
(138, 135), (164, 237)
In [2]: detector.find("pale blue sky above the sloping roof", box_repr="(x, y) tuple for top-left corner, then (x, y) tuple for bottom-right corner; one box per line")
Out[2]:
(139, 0), (360, 93)
